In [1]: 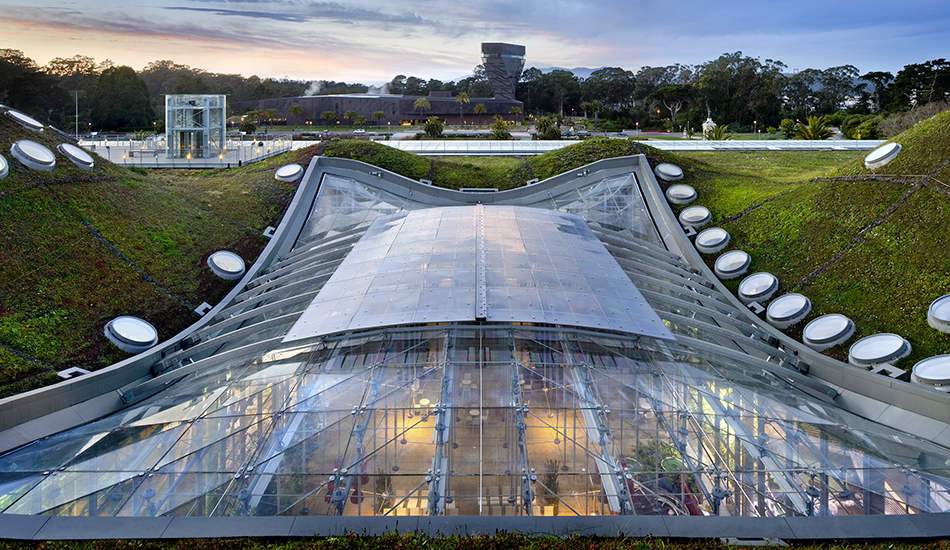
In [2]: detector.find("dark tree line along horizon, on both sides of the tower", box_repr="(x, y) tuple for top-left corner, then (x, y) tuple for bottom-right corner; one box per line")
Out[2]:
(0, 49), (950, 137)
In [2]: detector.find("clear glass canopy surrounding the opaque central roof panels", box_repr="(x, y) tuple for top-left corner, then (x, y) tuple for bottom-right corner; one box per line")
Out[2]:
(0, 166), (950, 517)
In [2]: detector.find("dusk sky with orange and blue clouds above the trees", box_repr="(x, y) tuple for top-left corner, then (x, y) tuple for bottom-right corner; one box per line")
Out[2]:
(0, 0), (950, 84)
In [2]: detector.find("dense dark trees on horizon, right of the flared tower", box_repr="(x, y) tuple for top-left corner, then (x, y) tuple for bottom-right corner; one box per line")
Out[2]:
(517, 52), (950, 138)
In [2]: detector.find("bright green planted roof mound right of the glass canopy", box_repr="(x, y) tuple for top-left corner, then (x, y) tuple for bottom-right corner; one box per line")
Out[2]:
(680, 112), (950, 370)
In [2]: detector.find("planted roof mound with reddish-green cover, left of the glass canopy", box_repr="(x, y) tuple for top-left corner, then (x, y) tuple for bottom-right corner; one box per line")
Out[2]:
(0, 113), (312, 397)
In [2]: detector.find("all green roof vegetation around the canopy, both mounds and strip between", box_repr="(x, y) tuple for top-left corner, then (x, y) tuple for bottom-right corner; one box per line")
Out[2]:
(0, 112), (950, 397)
